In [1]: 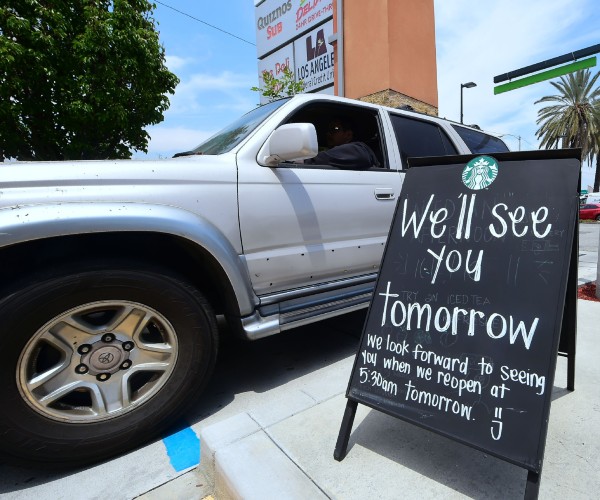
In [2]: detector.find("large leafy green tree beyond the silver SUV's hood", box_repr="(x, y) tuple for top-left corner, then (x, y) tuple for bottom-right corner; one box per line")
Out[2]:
(0, 0), (179, 160)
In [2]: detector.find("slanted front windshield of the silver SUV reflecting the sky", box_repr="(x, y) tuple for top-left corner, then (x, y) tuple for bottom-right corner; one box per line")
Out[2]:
(175, 98), (289, 156)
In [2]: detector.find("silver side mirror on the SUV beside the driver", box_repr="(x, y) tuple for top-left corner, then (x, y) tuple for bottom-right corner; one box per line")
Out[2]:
(257, 123), (319, 167)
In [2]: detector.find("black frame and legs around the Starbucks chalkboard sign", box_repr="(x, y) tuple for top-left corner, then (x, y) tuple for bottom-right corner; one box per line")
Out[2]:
(334, 149), (581, 498)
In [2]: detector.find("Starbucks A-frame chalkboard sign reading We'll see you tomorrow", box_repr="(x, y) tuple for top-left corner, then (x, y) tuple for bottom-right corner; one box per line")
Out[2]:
(334, 150), (580, 498)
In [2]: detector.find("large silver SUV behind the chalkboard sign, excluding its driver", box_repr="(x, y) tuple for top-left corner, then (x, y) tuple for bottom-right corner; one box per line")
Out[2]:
(0, 94), (508, 466)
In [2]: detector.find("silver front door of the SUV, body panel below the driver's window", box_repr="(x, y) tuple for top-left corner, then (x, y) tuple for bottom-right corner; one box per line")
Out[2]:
(238, 108), (403, 295)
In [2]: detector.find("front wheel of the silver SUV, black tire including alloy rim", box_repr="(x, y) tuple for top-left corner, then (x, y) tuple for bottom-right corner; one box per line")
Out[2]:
(0, 264), (218, 468)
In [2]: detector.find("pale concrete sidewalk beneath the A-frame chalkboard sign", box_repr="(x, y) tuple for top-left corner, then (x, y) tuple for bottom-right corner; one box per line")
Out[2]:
(191, 300), (600, 500)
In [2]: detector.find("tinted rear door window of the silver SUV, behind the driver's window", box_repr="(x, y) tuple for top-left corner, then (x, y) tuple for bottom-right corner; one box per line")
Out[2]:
(390, 114), (458, 168)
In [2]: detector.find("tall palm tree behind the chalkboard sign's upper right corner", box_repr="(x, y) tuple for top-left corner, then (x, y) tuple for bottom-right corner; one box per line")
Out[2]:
(535, 69), (600, 191)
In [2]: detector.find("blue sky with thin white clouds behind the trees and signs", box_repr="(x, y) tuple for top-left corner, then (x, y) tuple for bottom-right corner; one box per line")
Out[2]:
(144, 0), (600, 189)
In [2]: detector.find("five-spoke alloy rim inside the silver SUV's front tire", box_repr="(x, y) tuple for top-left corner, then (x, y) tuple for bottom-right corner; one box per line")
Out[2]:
(16, 301), (178, 423)
